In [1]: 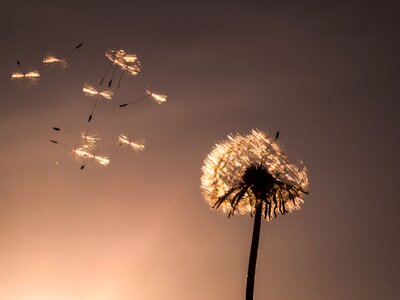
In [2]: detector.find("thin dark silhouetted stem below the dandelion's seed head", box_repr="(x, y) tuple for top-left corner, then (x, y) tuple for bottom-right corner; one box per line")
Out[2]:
(246, 204), (262, 300)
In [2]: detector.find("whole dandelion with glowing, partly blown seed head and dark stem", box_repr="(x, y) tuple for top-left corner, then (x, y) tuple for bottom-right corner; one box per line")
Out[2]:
(201, 130), (309, 300)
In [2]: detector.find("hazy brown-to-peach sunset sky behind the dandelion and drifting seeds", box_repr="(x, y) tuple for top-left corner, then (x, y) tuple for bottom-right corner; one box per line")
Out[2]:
(0, 1), (400, 300)
